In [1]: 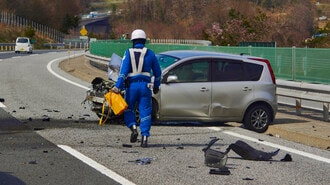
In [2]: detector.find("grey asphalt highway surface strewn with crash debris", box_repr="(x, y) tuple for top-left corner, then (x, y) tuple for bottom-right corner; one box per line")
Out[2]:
(0, 51), (330, 185)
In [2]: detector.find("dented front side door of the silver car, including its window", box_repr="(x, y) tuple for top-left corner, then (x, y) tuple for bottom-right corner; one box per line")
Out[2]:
(160, 60), (211, 120)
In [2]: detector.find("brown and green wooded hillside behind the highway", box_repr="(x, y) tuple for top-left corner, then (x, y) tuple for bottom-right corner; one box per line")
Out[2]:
(0, 0), (330, 48)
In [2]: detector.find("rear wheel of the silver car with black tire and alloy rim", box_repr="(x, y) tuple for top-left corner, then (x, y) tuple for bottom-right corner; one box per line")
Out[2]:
(243, 105), (272, 133)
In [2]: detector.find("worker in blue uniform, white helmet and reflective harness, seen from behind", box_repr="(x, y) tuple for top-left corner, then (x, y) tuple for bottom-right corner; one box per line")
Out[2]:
(112, 29), (161, 147)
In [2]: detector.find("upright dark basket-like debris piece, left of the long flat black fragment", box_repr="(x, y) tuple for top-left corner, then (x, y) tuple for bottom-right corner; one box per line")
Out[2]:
(202, 138), (229, 169)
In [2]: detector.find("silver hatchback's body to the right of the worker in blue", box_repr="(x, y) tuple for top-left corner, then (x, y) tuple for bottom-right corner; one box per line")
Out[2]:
(153, 50), (277, 132)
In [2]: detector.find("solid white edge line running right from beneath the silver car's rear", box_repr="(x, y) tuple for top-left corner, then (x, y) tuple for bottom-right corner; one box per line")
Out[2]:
(209, 127), (330, 163)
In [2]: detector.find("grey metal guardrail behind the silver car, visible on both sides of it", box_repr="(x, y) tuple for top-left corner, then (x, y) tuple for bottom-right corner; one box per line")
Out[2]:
(85, 52), (330, 121)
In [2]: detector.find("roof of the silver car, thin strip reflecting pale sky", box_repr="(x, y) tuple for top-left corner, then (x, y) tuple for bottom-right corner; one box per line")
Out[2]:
(159, 50), (260, 59)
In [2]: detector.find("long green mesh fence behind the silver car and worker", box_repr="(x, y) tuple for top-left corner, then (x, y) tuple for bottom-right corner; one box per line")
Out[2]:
(90, 40), (330, 84)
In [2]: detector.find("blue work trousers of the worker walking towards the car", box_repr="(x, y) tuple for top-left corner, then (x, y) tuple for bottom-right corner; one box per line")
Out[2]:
(124, 82), (152, 137)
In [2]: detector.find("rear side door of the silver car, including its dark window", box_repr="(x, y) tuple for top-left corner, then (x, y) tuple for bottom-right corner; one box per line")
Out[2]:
(211, 59), (255, 121)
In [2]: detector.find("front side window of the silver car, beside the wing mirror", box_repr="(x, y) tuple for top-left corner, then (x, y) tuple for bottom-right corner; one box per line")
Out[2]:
(169, 60), (209, 82)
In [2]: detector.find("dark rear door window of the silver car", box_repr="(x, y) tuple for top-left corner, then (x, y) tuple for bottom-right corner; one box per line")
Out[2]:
(213, 59), (244, 82)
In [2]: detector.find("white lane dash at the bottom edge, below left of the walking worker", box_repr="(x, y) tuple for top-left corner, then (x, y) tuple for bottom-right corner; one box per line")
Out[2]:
(57, 145), (134, 185)
